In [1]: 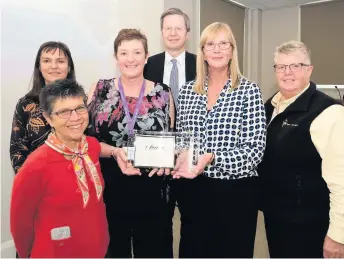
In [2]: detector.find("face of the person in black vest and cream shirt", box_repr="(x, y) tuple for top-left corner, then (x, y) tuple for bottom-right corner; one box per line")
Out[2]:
(275, 50), (313, 99)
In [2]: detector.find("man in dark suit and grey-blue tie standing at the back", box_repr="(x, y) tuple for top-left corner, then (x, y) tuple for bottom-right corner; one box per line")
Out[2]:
(144, 8), (196, 114)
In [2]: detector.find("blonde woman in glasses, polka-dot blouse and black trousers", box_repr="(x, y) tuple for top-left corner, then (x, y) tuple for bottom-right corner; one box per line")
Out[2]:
(172, 22), (266, 258)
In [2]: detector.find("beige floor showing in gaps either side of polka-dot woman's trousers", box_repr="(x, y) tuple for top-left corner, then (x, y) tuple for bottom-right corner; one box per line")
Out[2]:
(173, 209), (269, 258)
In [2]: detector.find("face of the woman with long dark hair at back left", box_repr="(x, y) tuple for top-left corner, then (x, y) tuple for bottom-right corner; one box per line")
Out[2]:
(39, 49), (69, 84)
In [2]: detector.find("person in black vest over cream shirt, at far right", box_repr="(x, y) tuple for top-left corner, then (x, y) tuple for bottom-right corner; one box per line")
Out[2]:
(258, 41), (344, 258)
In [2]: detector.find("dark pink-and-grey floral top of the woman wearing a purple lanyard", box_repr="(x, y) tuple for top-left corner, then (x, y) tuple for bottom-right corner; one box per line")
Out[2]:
(88, 78), (170, 147)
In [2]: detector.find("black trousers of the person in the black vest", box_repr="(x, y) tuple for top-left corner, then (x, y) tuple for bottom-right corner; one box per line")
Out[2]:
(264, 215), (329, 258)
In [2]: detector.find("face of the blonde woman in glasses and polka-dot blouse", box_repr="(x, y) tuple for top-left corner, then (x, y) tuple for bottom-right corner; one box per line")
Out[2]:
(203, 31), (233, 70)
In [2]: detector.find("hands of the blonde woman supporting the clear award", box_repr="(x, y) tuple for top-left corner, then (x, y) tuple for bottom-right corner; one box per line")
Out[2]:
(171, 153), (214, 179)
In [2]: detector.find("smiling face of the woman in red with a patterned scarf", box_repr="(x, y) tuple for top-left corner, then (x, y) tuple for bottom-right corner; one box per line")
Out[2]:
(45, 97), (88, 147)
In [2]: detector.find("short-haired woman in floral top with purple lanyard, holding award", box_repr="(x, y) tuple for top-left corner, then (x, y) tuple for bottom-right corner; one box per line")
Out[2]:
(88, 29), (174, 258)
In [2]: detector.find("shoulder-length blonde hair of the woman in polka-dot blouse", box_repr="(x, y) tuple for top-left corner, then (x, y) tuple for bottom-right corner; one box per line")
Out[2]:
(194, 22), (241, 94)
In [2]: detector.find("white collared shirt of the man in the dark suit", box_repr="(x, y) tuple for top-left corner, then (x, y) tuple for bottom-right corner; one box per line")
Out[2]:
(163, 51), (186, 89)
